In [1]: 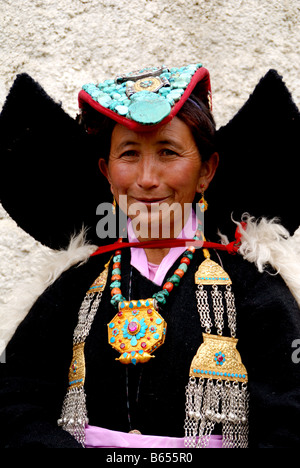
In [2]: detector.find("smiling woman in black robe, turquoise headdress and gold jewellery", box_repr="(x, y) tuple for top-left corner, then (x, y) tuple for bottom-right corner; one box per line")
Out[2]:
(1, 64), (300, 448)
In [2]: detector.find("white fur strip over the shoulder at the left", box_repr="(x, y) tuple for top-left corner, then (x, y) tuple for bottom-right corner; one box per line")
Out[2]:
(0, 230), (97, 355)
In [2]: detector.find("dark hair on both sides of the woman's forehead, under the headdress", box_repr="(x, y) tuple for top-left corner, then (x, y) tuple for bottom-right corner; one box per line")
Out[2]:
(77, 94), (216, 161)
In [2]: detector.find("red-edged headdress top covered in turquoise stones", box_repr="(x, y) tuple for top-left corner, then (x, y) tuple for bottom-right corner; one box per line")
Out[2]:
(79, 63), (211, 131)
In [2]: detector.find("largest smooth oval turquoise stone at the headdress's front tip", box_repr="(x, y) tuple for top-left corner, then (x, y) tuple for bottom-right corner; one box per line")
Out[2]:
(129, 91), (171, 124)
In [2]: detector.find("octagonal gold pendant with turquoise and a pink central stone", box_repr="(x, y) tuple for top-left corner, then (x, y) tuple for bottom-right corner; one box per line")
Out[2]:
(107, 298), (167, 364)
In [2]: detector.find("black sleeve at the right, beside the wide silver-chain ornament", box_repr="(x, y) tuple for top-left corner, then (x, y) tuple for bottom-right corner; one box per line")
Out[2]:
(231, 262), (300, 448)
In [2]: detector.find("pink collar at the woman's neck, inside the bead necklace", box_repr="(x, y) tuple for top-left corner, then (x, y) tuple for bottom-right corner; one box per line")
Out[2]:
(127, 210), (198, 286)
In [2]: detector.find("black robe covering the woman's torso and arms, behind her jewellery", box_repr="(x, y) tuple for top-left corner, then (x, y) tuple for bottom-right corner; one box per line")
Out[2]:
(0, 249), (300, 448)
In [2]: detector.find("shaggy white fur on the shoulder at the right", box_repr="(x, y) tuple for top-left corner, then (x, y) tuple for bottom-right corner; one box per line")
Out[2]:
(236, 215), (300, 306)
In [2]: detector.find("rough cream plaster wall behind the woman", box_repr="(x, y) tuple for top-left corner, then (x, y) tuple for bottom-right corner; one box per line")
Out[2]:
(0, 0), (300, 310)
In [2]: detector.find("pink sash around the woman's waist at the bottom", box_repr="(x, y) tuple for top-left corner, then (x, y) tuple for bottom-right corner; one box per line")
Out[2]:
(85, 426), (222, 448)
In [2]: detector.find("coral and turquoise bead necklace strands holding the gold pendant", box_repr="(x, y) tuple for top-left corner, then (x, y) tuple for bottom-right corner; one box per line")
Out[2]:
(110, 221), (204, 309)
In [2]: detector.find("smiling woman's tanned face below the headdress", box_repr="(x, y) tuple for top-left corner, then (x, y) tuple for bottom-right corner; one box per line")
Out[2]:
(99, 117), (218, 238)
